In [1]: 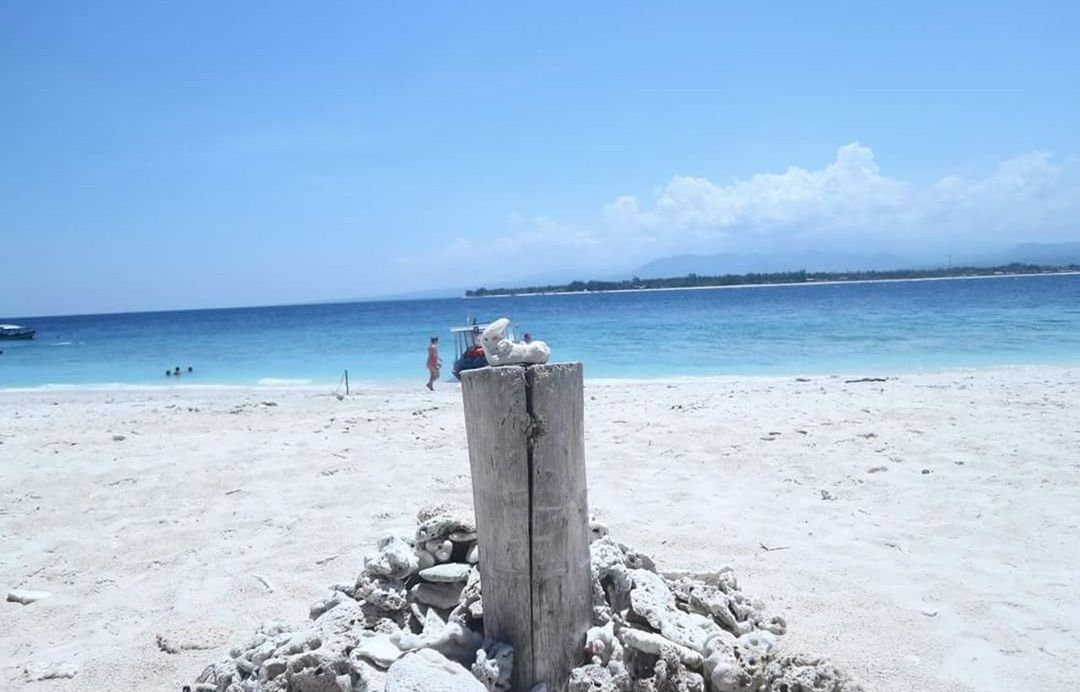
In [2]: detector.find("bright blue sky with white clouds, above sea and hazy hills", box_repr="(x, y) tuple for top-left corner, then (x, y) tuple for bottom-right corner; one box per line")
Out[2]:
(0, 1), (1080, 315)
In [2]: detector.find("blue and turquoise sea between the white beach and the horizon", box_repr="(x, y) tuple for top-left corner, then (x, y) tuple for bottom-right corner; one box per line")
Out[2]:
(0, 275), (1080, 388)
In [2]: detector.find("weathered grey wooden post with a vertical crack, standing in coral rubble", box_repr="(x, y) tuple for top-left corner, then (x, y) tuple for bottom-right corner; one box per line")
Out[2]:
(461, 363), (592, 692)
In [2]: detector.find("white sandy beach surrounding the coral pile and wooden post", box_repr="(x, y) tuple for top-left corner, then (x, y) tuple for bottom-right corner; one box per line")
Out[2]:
(0, 367), (1080, 692)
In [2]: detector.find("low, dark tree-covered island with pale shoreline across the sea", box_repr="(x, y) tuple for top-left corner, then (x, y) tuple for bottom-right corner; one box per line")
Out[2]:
(465, 262), (1080, 298)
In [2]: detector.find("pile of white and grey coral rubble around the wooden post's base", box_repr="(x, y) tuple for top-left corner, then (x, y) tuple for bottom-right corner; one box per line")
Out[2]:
(192, 505), (862, 692)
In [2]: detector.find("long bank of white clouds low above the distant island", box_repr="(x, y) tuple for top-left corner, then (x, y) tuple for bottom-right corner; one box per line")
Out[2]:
(443, 141), (1080, 275)
